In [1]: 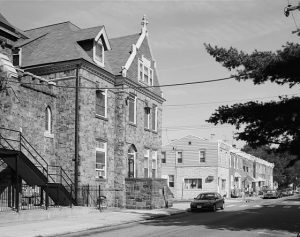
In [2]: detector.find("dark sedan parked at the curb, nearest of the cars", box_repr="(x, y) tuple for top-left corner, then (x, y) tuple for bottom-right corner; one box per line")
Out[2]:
(190, 192), (225, 212)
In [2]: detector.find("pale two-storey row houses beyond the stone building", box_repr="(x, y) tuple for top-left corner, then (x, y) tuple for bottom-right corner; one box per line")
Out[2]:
(161, 135), (274, 199)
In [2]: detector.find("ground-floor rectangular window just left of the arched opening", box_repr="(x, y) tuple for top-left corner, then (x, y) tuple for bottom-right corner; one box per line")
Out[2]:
(96, 141), (107, 179)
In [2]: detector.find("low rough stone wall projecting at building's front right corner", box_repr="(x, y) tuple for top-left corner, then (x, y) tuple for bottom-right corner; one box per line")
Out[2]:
(125, 178), (173, 209)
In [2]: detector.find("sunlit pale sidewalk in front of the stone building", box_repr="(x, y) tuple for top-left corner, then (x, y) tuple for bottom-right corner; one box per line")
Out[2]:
(0, 203), (189, 237)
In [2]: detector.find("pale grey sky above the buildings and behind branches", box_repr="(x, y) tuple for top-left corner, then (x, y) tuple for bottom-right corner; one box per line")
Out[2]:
(0, 0), (300, 147)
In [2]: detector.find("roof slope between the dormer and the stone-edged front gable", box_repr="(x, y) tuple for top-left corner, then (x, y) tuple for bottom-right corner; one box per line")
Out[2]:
(105, 34), (140, 75)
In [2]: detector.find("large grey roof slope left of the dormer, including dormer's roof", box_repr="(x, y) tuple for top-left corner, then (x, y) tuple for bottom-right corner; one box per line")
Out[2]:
(15, 22), (115, 72)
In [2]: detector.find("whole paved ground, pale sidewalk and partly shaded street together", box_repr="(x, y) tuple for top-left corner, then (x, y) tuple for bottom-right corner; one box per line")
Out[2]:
(0, 196), (300, 237)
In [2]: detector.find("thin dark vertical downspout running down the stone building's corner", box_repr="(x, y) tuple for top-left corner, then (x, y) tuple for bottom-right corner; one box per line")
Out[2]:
(74, 64), (80, 204)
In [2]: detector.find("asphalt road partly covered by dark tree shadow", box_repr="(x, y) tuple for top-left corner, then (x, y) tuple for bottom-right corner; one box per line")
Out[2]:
(61, 196), (300, 237)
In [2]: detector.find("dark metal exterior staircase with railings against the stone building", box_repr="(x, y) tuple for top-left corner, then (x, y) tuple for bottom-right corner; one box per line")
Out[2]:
(0, 127), (75, 206)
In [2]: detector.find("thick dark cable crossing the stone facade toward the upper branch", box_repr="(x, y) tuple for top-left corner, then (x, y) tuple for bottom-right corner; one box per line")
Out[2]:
(8, 76), (236, 90)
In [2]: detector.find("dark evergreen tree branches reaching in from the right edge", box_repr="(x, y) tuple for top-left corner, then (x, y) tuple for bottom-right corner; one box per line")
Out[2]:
(205, 43), (300, 164)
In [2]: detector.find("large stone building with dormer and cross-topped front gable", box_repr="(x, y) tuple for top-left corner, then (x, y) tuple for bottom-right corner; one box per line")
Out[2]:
(0, 12), (165, 207)
